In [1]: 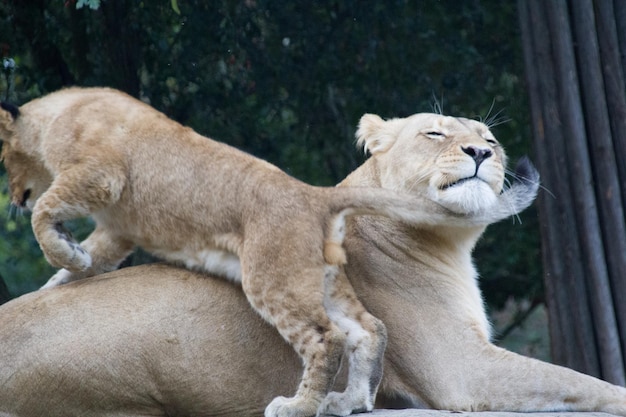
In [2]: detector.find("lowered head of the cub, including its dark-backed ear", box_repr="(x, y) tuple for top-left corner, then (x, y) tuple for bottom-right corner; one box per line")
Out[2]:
(0, 103), (52, 209)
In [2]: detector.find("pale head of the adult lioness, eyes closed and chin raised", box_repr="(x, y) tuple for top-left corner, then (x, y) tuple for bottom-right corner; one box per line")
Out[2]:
(357, 113), (506, 213)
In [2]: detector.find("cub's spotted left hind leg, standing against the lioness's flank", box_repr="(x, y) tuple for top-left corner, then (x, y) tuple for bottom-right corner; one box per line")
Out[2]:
(242, 257), (345, 417)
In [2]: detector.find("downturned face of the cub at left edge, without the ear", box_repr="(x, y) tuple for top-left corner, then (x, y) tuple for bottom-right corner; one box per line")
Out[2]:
(0, 142), (52, 210)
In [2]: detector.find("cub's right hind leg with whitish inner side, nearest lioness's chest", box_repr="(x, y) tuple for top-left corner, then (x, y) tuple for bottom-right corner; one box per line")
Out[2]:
(319, 267), (387, 416)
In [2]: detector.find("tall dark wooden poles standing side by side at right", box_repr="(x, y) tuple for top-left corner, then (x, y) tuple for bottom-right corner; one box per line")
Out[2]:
(518, 0), (626, 385)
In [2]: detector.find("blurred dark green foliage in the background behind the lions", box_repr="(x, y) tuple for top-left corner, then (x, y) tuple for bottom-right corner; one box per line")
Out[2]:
(0, 0), (542, 307)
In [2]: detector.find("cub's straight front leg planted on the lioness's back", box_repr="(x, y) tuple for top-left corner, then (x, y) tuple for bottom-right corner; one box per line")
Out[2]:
(41, 227), (133, 289)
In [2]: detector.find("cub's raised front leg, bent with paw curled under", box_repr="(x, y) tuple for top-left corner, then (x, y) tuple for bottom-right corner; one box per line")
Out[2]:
(31, 167), (124, 272)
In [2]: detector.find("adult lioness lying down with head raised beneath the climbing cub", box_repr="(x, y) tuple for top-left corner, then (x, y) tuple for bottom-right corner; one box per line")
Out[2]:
(0, 111), (626, 417)
